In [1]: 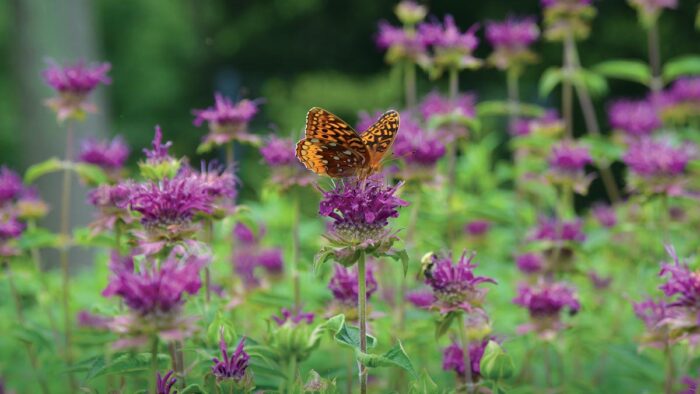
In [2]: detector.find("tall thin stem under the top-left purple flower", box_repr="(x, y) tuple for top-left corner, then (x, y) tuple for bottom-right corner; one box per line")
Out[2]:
(60, 122), (77, 392)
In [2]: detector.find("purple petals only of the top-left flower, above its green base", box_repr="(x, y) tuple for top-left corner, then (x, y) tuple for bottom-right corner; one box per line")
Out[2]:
(42, 61), (112, 95)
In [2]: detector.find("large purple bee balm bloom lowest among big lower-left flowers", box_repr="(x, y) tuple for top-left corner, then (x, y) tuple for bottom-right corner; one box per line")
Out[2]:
(102, 253), (209, 317)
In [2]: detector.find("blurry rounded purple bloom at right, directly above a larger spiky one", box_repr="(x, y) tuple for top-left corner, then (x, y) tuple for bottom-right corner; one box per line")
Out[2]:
(608, 100), (661, 137)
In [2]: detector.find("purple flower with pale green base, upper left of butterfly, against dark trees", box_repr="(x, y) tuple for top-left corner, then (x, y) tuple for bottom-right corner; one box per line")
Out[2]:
(192, 93), (259, 145)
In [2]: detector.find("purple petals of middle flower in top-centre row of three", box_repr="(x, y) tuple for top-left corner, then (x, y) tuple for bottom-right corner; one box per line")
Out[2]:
(418, 15), (479, 53)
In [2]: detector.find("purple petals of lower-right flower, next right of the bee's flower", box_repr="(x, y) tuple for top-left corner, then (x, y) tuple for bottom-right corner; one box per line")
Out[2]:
(513, 283), (581, 318)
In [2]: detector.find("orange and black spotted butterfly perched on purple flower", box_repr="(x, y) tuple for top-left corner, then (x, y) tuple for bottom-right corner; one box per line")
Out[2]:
(296, 107), (399, 178)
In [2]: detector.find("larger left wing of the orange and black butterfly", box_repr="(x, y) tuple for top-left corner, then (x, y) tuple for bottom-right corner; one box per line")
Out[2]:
(296, 107), (370, 178)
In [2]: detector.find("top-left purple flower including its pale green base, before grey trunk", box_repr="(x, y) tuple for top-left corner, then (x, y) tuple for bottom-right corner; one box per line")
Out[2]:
(42, 61), (111, 121)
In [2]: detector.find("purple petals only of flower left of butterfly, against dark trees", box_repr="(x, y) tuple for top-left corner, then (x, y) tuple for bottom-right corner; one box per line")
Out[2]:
(192, 93), (259, 127)
